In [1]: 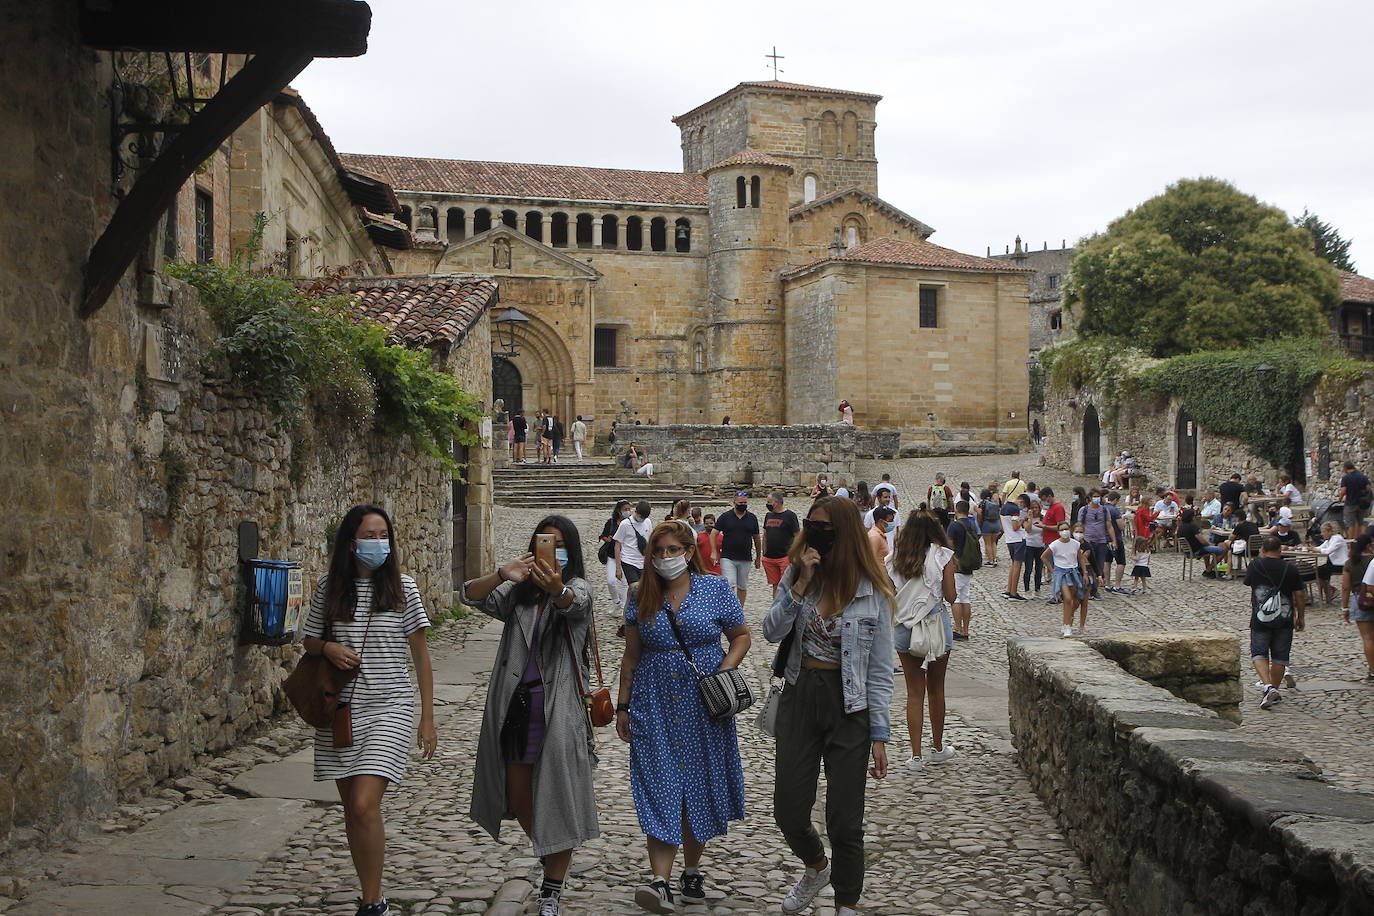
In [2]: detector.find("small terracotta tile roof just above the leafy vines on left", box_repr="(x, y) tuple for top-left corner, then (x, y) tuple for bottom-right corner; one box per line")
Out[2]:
(323, 276), (497, 349)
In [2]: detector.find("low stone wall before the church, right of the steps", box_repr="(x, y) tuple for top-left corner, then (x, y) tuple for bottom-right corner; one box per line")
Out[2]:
(625, 423), (900, 489)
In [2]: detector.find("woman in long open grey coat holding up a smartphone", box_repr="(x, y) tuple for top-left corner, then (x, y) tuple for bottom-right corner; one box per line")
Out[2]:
(463, 515), (600, 916)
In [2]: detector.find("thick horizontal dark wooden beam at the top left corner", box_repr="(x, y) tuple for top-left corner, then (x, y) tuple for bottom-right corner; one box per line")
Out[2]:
(81, 0), (372, 58)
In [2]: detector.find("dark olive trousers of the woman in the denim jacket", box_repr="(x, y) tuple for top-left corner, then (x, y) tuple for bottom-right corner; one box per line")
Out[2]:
(774, 665), (872, 906)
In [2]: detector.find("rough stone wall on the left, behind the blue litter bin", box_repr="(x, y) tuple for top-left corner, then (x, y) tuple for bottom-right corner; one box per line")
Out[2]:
(0, 4), (467, 850)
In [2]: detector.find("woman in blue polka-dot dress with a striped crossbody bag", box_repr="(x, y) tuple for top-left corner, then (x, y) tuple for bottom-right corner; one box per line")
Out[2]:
(616, 519), (749, 913)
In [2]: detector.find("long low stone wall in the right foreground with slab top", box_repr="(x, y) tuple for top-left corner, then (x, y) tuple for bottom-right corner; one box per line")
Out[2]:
(1007, 639), (1374, 916)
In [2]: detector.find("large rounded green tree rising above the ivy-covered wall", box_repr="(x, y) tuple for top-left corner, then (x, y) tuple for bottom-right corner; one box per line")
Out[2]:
(1066, 179), (1341, 357)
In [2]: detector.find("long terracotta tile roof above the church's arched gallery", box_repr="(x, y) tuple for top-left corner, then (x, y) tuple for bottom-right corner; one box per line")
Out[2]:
(335, 152), (706, 206)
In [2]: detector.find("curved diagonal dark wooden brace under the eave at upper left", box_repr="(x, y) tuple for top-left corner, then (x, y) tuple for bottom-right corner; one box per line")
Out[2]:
(80, 54), (311, 317)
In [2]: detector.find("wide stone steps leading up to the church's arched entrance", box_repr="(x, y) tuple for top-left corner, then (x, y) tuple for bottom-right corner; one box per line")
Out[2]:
(492, 456), (694, 518)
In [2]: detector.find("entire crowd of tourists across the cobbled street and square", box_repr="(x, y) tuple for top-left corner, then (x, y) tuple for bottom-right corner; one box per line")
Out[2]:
(292, 455), (1374, 916)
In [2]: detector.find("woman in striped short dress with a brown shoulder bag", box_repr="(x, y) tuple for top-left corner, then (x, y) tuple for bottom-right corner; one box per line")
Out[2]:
(305, 505), (438, 916)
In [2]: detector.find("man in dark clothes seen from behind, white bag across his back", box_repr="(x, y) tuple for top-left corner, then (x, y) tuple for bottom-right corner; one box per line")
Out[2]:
(1245, 537), (1307, 709)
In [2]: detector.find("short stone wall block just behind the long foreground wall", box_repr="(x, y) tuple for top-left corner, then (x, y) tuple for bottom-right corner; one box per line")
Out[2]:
(1088, 630), (1242, 724)
